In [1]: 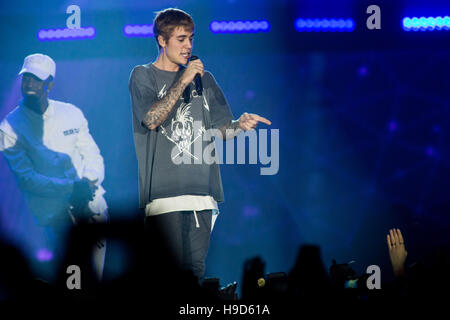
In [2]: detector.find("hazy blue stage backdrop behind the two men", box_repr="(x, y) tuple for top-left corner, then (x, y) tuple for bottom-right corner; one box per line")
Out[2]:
(0, 0), (450, 292)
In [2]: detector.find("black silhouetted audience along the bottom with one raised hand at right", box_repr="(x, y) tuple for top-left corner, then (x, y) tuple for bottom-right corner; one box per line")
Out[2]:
(0, 208), (450, 318)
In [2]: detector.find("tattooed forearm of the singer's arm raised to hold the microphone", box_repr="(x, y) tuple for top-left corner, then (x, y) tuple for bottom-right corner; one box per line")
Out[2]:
(142, 80), (186, 130)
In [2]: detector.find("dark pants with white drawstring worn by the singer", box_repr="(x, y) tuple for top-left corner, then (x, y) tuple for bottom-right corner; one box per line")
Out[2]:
(145, 210), (212, 281)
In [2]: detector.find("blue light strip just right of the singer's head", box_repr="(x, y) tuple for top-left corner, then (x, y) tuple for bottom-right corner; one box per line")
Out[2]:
(209, 20), (270, 33)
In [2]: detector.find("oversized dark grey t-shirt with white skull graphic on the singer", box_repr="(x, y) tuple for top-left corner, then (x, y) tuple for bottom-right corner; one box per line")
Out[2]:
(129, 64), (233, 208)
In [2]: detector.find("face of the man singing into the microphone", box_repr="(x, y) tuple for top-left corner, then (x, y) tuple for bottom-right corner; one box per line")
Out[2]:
(165, 27), (194, 65)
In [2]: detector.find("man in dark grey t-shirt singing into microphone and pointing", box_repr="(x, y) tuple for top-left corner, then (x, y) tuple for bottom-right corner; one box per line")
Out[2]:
(129, 8), (270, 281)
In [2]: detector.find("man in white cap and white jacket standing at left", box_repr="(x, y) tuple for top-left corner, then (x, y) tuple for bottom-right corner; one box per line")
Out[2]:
(0, 53), (108, 280)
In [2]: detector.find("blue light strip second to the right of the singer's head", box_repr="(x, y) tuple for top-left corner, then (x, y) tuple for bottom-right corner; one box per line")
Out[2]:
(295, 18), (355, 32)
